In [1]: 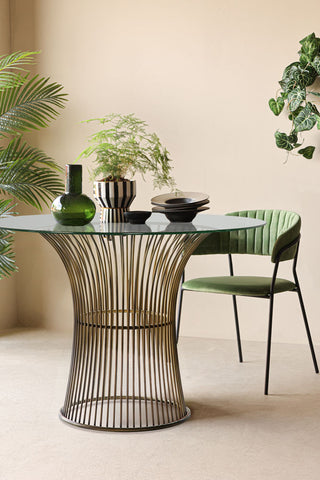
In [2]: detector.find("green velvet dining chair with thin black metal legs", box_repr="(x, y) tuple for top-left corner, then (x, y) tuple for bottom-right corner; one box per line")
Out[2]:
(177, 210), (319, 395)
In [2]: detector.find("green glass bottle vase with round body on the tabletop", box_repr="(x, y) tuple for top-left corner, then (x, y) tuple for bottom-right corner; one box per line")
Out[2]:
(51, 165), (96, 225)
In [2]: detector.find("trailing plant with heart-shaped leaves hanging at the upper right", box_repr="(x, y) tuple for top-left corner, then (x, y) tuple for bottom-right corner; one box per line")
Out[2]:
(269, 33), (320, 159)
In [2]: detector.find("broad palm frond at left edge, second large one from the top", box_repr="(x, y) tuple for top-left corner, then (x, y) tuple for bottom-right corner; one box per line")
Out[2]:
(0, 75), (66, 136)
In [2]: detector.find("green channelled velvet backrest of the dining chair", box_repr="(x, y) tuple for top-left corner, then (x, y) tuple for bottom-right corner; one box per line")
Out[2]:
(193, 210), (301, 262)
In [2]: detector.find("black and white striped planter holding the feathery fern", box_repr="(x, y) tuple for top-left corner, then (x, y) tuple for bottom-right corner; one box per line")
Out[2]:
(93, 180), (136, 223)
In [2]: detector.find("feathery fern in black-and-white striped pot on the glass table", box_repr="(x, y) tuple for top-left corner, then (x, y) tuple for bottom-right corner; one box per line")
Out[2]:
(78, 113), (175, 222)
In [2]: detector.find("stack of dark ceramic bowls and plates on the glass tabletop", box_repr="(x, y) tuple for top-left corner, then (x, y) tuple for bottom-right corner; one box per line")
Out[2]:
(151, 192), (209, 222)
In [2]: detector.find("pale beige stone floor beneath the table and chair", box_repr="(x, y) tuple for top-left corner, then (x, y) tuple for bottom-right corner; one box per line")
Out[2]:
(0, 331), (320, 480)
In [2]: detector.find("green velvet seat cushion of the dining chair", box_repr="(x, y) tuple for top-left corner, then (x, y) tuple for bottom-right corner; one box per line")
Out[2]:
(183, 276), (296, 297)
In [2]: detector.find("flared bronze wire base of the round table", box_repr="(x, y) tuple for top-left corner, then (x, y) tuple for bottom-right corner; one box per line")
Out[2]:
(41, 233), (208, 431)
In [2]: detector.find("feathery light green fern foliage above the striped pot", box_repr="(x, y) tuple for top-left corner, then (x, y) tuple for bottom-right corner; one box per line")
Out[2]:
(78, 113), (175, 188)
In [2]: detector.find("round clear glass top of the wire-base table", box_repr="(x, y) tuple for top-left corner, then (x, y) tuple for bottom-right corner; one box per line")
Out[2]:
(0, 213), (266, 235)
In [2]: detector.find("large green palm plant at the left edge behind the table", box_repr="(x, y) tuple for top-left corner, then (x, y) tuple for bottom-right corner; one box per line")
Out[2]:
(0, 52), (66, 278)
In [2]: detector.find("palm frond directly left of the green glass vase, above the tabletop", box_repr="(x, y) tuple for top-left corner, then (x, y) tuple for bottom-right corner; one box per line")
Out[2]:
(0, 138), (64, 210)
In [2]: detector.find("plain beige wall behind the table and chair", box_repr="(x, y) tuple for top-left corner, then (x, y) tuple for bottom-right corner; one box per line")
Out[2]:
(3, 0), (320, 343)
